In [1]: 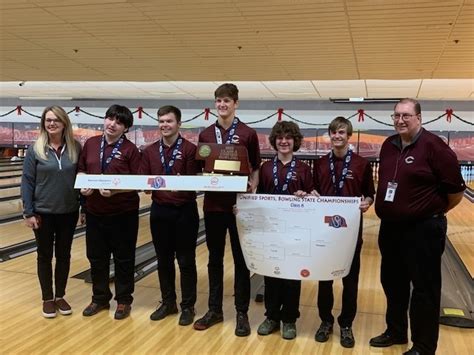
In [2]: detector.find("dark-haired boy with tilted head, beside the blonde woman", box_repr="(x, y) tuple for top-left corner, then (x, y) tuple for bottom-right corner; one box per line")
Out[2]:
(78, 105), (140, 319)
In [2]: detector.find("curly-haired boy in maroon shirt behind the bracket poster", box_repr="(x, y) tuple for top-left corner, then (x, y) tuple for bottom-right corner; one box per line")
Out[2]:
(257, 121), (313, 340)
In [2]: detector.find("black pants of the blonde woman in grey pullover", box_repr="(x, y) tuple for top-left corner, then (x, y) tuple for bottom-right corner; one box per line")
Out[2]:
(33, 211), (79, 301)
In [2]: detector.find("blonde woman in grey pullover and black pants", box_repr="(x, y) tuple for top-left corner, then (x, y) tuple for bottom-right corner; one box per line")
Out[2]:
(21, 106), (81, 318)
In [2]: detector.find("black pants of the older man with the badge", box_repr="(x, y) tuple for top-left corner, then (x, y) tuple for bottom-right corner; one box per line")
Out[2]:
(379, 217), (447, 354)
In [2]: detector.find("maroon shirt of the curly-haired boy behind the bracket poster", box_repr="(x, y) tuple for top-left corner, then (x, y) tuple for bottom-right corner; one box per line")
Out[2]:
(257, 159), (313, 195)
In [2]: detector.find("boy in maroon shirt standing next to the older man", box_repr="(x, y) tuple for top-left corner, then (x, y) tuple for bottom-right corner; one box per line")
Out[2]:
(313, 117), (375, 348)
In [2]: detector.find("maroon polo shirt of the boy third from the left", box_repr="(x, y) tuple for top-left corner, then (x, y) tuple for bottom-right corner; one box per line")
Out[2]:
(140, 138), (199, 206)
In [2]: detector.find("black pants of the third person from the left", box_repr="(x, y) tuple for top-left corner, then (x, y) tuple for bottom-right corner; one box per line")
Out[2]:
(150, 201), (199, 309)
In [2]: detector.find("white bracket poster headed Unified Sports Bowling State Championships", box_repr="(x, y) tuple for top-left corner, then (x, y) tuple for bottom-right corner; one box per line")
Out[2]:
(237, 194), (361, 280)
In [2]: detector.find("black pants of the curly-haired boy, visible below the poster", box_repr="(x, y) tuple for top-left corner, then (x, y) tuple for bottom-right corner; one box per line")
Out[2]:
(265, 276), (301, 323)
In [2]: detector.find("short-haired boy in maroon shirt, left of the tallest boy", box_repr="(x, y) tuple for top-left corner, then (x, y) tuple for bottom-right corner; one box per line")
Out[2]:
(140, 106), (199, 325)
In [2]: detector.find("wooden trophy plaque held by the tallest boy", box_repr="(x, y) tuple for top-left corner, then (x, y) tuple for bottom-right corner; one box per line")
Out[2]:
(196, 143), (250, 175)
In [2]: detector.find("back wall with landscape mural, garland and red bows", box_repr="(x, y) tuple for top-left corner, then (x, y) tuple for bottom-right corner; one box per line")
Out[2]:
(0, 99), (474, 165)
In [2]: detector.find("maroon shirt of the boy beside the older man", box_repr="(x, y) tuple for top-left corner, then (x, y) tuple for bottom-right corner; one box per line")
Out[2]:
(313, 153), (375, 200)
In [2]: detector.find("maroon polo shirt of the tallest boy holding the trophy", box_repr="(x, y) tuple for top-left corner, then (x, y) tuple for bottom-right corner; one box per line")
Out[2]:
(199, 121), (261, 212)
